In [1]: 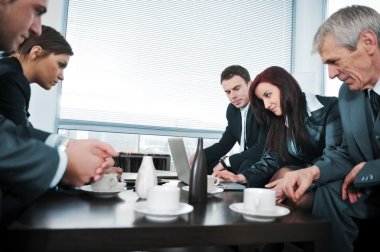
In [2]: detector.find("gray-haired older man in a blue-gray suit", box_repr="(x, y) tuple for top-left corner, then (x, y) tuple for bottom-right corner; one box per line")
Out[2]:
(274, 5), (380, 252)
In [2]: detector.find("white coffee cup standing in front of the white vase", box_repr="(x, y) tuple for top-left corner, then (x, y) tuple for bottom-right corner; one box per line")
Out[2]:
(147, 186), (180, 213)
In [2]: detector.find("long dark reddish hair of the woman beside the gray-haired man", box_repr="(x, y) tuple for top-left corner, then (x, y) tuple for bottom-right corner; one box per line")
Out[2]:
(249, 66), (309, 160)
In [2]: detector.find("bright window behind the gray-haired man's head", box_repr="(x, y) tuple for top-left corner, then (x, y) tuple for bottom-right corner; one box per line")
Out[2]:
(325, 0), (380, 96)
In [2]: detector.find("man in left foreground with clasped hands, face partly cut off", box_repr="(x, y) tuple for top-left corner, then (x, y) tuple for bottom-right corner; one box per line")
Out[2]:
(0, 0), (118, 228)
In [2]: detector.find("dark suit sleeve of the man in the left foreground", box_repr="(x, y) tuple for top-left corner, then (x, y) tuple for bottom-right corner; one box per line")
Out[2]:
(0, 115), (59, 227)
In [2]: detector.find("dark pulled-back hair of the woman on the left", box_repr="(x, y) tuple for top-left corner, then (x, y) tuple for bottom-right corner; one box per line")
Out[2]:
(16, 25), (74, 57)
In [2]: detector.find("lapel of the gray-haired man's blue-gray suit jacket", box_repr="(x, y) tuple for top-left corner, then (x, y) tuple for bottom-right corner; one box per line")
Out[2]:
(350, 92), (373, 160)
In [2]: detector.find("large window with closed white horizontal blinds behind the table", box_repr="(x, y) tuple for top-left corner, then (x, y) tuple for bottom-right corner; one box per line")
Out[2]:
(58, 0), (293, 151)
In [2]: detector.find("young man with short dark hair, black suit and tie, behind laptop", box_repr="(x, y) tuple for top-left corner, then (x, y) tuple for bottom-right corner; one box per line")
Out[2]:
(200, 65), (267, 174)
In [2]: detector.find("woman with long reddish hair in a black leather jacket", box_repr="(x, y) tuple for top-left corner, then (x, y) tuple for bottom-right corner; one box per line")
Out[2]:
(215, 66), (342, 209)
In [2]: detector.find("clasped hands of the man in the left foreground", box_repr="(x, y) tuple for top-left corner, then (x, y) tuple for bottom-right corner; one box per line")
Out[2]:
(62, 140), (119, 186)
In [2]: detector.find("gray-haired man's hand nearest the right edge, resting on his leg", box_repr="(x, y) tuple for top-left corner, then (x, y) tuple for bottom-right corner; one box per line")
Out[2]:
(342, 162), (366, 203)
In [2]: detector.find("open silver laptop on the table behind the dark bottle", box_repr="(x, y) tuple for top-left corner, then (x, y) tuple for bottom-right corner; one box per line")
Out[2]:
(168, 138), (246, 191)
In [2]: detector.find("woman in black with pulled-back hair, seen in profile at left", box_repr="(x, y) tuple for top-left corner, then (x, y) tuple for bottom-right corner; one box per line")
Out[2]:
(0, 25), (74, 126)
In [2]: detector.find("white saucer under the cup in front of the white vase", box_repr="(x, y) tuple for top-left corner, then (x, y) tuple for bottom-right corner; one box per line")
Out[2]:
(134, 201), (193, 221)
